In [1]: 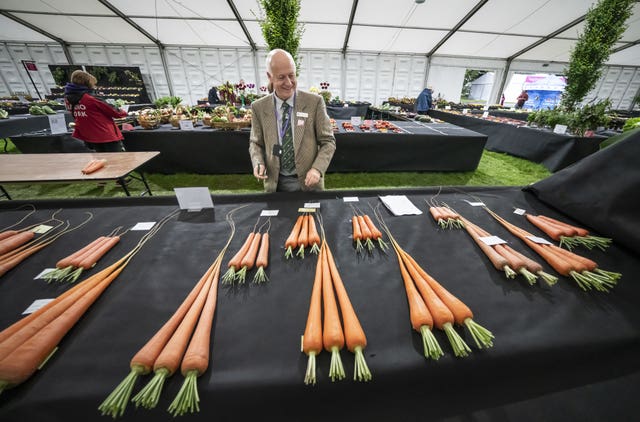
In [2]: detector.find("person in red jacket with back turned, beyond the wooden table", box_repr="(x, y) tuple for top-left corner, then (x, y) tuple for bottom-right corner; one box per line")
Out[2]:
(64, 70), (127, 152)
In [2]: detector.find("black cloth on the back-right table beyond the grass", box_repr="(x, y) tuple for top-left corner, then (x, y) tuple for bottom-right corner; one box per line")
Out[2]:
(429, 110), (606, 172)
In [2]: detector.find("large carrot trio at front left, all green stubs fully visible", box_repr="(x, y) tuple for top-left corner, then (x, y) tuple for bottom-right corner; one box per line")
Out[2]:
(98, 206), (235, 418)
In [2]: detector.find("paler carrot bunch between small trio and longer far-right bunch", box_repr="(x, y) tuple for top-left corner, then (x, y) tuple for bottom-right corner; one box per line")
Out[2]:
(460, 217), (558, 286)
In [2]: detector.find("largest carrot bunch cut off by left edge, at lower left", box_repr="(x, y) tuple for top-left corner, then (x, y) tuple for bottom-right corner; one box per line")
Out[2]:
(0, 211), (178, 393)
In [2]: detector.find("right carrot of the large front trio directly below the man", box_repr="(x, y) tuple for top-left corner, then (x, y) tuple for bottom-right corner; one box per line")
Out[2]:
(322, 242), (371, 381)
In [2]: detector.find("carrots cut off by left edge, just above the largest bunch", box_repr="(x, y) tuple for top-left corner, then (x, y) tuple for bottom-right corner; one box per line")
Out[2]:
(0, 210), (93, 277)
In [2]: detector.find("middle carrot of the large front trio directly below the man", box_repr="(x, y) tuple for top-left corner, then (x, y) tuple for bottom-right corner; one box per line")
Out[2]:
(322, 242), (345, 381)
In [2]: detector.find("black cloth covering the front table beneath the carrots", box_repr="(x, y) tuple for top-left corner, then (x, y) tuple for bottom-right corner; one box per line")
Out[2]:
(0, 187), (640, 422)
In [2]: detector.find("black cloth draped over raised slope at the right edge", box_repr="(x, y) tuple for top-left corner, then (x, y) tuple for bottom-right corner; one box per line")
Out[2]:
(527, 133), (640, 254)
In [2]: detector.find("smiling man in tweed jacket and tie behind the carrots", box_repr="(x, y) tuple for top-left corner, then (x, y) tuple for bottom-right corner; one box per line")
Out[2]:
(249, 49), (336, 192)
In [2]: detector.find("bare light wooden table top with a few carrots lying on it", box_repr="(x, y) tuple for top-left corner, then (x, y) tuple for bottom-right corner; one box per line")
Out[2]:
(0, 151), (160, 183)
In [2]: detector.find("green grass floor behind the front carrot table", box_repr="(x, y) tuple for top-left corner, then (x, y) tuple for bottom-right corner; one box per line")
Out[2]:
(3, 137), (551, 200)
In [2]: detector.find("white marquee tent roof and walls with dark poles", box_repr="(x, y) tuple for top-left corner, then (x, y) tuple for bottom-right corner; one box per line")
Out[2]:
(0, 0), (640, 109)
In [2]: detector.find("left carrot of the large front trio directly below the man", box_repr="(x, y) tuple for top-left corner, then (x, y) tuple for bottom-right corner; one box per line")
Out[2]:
(302, 244), (324, 385)
